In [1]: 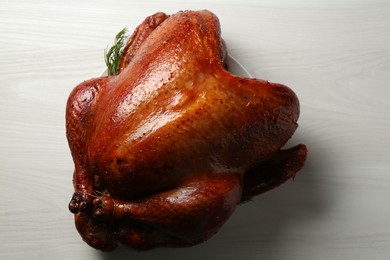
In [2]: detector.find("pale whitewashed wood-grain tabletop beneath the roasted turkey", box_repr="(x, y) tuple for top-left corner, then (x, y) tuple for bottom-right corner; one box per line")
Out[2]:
(0, 0), (390, 260)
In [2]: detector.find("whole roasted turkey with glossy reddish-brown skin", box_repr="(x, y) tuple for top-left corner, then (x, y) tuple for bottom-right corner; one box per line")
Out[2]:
(66, 11), (307, 251)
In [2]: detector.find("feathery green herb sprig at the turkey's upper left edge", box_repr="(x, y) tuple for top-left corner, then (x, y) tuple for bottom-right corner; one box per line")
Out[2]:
(104, 28), (127, 75)
